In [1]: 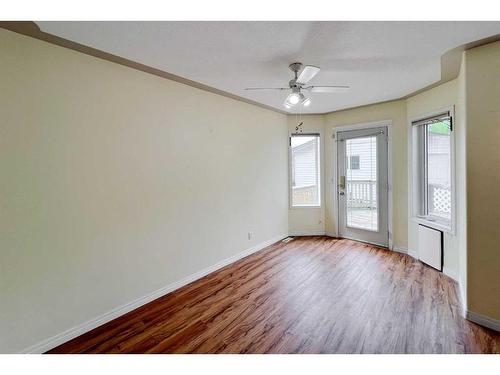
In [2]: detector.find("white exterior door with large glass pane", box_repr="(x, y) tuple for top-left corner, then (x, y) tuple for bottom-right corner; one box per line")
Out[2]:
(337, 127), (389, 246)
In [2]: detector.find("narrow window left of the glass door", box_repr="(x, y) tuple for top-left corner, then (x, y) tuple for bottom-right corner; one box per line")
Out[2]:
(290, 134), (321, 207)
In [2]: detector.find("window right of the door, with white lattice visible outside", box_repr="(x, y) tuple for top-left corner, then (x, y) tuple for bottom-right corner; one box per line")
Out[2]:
(412, 112), (452, 228)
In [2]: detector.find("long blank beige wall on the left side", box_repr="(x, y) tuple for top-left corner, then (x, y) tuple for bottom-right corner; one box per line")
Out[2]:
(0, 30), (288, 352)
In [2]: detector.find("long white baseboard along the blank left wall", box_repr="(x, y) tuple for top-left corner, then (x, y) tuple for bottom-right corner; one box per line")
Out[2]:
(21, 234), (287, 354)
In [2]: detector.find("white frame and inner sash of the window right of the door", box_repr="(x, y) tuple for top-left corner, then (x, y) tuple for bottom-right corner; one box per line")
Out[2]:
(408, 106), (456, 234)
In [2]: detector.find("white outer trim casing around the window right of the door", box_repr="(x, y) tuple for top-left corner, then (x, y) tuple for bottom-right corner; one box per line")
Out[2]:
(407, 105), (457, 235)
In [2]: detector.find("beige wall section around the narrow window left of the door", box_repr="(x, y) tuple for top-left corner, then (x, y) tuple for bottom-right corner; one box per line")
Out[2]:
(287, 115), (328, 235)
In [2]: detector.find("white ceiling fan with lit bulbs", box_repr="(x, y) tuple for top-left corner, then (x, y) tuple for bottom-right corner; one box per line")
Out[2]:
(245, 62), (349, 109)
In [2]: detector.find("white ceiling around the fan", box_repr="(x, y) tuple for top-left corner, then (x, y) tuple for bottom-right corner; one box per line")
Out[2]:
(37, 21), (500, 113)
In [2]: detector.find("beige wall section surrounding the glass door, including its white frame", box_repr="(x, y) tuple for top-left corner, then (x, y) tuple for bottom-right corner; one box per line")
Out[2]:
(324, 100), (408, 249)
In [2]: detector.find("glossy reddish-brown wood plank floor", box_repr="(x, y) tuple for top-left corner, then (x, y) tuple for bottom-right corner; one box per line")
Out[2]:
(49, 237), (500, 353)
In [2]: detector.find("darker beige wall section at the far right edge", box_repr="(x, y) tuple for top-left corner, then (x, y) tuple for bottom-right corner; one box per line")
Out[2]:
(465, 42), (500, 324)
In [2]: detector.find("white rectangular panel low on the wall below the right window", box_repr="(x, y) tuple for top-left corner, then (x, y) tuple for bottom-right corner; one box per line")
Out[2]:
(418, 224), (443, 271)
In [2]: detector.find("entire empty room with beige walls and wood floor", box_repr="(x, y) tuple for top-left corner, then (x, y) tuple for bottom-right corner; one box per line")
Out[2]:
(0, 2), (500, 365)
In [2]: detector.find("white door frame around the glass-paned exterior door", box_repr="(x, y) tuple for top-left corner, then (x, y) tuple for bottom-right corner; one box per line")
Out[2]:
(330, 120), (393, 250)
